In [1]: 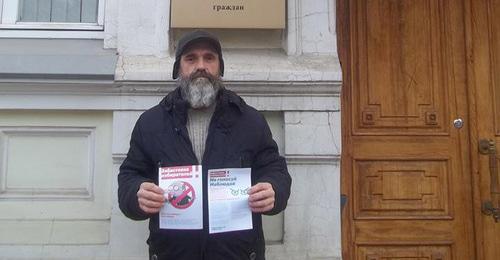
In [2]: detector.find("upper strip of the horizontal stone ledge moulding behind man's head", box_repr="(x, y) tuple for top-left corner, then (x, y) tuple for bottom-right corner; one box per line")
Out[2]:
(0, 79), (342, 97)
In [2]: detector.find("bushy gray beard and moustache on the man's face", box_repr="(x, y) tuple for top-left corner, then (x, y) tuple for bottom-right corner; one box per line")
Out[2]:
(180, 77), (221, 109)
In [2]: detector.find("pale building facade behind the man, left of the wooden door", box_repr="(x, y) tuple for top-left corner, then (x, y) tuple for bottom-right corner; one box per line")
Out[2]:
(0, 0), (342, 259)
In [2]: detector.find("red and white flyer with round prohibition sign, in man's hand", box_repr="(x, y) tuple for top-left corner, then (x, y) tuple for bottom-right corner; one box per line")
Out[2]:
(158, 165), (203, 229)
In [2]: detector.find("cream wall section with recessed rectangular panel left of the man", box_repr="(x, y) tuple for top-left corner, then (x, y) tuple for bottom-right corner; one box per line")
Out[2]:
(0, 110), (112, 259)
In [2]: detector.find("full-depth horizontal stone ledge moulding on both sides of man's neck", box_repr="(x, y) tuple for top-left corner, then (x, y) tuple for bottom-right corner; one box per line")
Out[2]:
(0, 79), (341, 111)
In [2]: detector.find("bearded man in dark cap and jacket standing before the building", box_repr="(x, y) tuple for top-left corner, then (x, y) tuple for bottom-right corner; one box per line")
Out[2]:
(118, 31), (291, 260)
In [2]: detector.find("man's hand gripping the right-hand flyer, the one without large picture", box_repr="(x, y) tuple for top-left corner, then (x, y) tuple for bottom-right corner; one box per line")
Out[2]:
(248, 182), (274, 213)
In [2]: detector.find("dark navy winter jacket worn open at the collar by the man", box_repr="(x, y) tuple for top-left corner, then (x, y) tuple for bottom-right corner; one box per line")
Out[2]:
(118, 88), (291, 260)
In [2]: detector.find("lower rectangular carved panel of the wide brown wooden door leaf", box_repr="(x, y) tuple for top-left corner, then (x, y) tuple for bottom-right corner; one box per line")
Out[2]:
(353, 158), (452, 219)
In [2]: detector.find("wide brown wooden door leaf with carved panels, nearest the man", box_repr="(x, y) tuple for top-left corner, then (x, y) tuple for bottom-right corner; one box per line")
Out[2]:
(337, 0), (475, 260)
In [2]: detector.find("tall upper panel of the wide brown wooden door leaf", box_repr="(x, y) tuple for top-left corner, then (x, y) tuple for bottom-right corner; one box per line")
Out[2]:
(352, 0), (451, 135)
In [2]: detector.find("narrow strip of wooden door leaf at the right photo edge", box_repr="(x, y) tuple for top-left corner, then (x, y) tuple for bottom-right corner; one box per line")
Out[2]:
(467, 0), (500, 260)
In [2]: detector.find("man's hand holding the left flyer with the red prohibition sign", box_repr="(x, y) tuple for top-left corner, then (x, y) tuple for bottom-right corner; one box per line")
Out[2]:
(137, 182), (165, 214)
